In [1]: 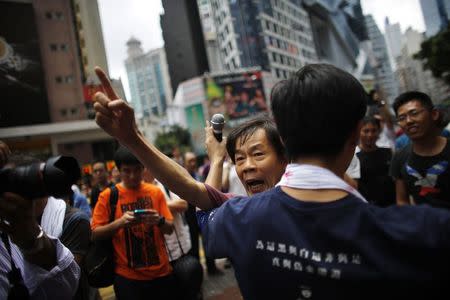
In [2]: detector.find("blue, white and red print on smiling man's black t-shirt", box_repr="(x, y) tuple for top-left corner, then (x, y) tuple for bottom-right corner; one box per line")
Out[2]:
(406, 161), (448, 197)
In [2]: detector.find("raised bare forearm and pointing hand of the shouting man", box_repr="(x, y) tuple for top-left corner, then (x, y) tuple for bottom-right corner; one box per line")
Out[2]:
(94, 67), (212, 209)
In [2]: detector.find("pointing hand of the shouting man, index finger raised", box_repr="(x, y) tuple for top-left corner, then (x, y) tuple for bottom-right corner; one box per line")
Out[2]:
(94, 67), (139, 145)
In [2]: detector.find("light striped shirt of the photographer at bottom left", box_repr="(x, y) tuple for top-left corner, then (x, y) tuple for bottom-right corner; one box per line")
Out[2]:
(0, 237), (80, 299)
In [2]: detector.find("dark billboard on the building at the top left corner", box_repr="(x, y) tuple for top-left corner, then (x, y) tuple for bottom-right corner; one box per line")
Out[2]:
(0, 1), (50, 127)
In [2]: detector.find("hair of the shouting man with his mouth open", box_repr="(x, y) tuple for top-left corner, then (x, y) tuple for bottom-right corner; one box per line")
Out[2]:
(226, 116), (286, 163)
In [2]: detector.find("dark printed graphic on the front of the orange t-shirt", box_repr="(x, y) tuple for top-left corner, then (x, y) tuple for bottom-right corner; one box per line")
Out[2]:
(121, 197), (160, 269)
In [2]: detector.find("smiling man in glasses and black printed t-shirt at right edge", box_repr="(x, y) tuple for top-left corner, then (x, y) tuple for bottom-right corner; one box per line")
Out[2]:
(391, 91), (450, 209)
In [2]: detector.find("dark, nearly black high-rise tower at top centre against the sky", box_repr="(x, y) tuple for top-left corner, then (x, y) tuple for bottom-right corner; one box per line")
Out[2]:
(161, 0), (209, 91)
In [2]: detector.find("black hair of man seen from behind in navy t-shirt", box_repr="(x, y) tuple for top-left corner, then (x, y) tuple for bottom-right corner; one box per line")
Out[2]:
(272, 64), (368, 159)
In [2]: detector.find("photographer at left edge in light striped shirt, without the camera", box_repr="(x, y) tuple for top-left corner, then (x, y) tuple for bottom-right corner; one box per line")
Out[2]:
(0, 143), (80, 299)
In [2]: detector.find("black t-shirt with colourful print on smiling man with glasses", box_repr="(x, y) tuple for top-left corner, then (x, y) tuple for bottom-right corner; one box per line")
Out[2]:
(391, 140), (450, 209)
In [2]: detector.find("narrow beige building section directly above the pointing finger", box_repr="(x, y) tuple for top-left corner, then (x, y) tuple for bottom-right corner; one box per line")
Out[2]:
(72, 0), (109, 83)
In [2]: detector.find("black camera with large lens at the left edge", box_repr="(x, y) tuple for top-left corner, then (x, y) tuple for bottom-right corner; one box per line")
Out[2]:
(0, 156), (81, 199)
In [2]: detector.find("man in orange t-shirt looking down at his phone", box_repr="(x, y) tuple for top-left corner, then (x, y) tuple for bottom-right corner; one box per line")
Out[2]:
(92, 147), (176, 299)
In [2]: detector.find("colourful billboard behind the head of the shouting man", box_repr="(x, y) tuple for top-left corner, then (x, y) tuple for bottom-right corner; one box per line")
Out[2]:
(205, 71), (269, 127)
